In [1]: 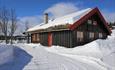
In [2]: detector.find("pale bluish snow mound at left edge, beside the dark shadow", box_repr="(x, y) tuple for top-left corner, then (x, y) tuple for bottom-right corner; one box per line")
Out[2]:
(0, 45), (13, 65)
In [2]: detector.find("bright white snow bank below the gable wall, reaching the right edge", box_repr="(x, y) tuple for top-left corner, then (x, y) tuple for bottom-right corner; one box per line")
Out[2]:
(46, 30), (115, 70)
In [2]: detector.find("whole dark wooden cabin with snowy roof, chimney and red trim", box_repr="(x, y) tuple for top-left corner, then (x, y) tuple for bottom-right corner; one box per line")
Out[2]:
(27, 7), (111, 48)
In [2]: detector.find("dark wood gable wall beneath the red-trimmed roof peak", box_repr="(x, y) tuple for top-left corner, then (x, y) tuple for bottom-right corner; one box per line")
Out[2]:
(72, 15), (108, 47)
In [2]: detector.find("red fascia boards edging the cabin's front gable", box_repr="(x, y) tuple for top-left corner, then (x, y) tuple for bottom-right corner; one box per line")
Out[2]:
(69, 7), (111, 34)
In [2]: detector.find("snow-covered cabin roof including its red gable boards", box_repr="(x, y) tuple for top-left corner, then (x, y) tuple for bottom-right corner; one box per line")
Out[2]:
(27, 8), (111, 34)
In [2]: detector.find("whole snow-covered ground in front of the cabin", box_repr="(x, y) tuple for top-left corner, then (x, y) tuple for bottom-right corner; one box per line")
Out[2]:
(0, 30), (115, 70)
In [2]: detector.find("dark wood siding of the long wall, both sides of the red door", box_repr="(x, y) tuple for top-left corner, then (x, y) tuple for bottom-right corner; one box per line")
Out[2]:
(37, 30), (72, 48)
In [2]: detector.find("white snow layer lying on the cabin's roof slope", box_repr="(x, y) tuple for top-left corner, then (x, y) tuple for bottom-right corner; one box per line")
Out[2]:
(27, 8), (92, 32)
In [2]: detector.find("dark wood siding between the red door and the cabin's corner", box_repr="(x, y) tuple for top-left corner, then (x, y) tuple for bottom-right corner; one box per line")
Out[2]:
(52, 31), (72, 48)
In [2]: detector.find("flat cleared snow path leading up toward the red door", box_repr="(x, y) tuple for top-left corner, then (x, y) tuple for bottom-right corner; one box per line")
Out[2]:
(18, 45), (106, 70)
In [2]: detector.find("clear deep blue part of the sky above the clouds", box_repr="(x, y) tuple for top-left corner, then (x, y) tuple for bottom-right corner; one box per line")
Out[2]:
(0, 0), (115, 17)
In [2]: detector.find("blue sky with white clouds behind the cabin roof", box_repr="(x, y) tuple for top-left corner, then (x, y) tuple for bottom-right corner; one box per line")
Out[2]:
(0, 0), (115, 34)
